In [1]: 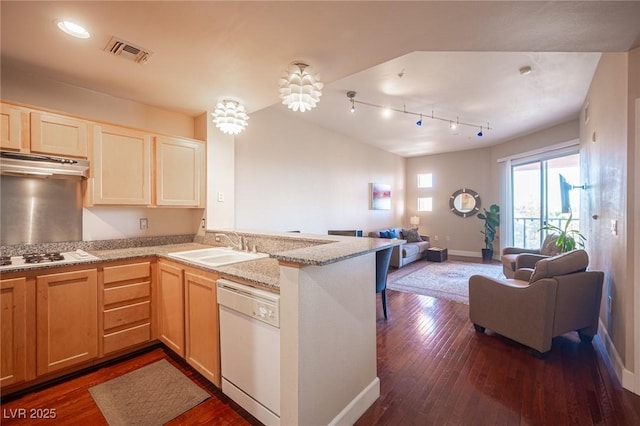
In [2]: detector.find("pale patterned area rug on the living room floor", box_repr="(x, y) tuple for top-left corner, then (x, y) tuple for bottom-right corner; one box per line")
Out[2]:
(387, 260), (504, 305)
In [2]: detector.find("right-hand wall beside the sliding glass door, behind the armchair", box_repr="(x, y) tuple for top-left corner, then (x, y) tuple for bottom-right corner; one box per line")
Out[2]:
(580, 53), (633, 374)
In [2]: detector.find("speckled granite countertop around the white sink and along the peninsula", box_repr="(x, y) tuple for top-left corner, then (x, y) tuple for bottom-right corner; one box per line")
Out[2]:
(0, 232), (405, 291)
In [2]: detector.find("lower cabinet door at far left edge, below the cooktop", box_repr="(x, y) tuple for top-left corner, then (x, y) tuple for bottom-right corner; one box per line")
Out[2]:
(0, 278), (27, 386)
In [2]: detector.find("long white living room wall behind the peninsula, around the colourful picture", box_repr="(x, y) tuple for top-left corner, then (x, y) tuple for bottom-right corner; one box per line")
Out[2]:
(235, 106), (405, 234)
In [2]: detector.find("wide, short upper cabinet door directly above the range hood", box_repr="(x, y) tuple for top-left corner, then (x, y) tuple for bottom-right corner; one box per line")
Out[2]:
(31, 112), (89, 158)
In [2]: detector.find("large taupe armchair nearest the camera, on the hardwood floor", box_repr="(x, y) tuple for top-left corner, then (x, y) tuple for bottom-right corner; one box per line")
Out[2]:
(469, 250), (604, 354)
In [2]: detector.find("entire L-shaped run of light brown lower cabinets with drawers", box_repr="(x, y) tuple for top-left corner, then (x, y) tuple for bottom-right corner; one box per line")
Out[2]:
(0, 259), (221, 393)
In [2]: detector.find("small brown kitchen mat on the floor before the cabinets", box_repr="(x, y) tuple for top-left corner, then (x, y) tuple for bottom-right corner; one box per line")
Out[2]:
(89, 359), (209, 426)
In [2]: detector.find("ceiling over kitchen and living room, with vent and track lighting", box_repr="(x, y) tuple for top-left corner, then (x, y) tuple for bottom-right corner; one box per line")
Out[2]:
(0, 0), (640, 157)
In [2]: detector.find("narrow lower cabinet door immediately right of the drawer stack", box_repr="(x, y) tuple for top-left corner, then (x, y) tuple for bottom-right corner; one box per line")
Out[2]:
(158, 262), (184, 358)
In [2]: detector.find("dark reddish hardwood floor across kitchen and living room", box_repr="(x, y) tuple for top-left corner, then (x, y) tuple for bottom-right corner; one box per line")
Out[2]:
(0, 258), (640, 426)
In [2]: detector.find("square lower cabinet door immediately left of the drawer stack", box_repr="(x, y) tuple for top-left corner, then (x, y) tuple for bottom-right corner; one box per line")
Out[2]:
(36, 269), (98, 375)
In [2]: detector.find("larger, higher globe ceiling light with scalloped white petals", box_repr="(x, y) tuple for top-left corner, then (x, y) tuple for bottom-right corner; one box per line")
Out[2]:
(279, 62), (324, 112)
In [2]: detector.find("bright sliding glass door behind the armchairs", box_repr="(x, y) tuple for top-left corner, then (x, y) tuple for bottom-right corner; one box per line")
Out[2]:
(510, 153), (580, 248)
